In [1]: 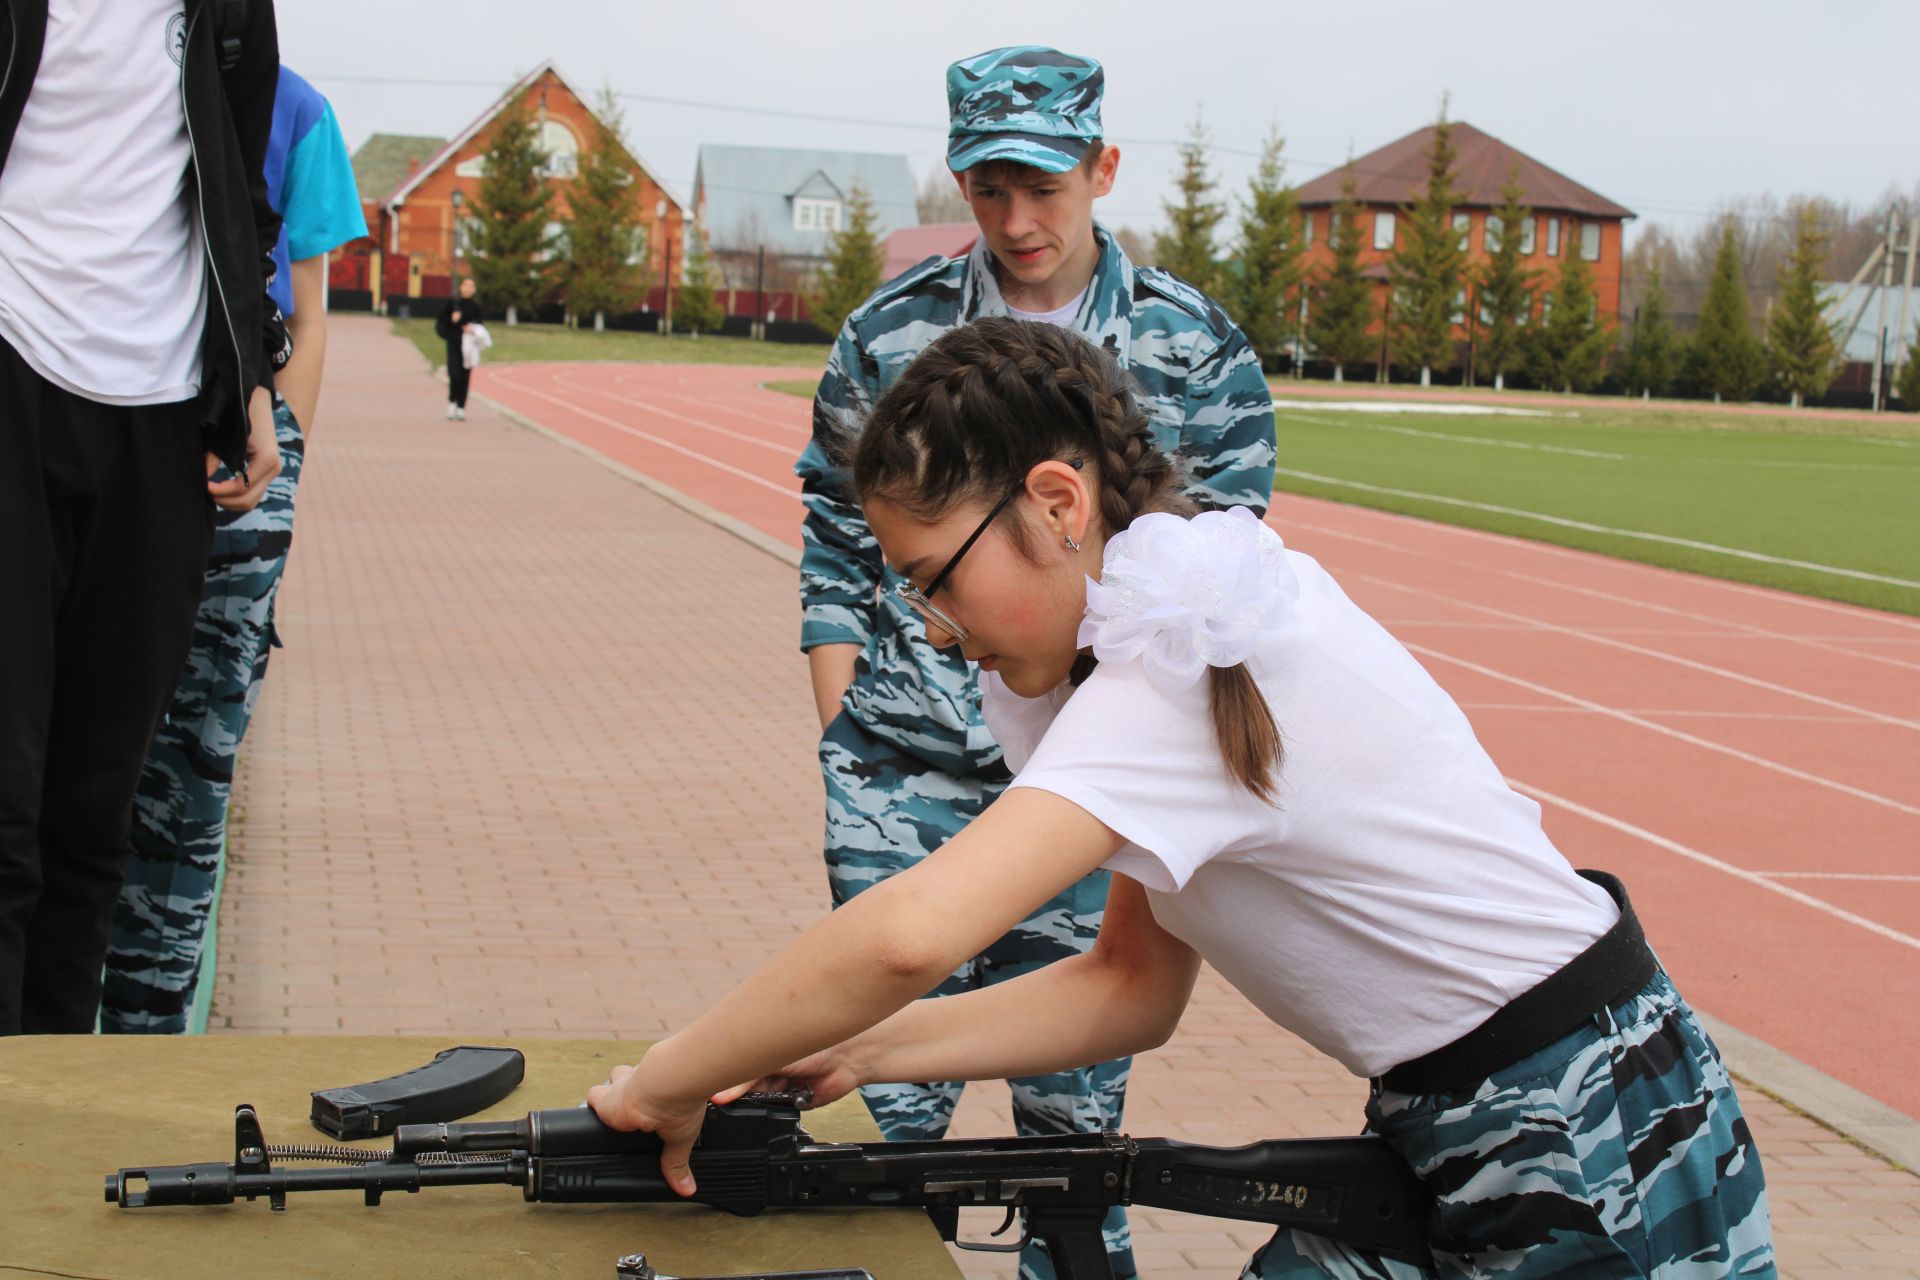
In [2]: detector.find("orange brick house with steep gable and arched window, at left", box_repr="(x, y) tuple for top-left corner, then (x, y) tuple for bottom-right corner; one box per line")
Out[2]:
(348, 61), (685, 307)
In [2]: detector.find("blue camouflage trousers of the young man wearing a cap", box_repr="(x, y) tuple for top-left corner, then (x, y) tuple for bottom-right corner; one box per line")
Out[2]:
(820, 712), (1135, 1280)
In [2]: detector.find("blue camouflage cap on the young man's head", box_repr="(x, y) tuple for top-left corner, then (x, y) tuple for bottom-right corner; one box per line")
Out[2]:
(947, 44), (1106, 173)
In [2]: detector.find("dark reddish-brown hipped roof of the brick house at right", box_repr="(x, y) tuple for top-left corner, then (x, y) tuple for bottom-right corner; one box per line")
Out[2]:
(1300, 121), (1636, 219)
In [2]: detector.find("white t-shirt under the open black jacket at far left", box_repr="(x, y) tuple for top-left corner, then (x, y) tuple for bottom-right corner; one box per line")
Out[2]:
(0, 0), (211, 405)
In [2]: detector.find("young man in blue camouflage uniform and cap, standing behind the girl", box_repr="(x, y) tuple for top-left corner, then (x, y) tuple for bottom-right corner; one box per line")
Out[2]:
(795, 46), (1273, 1280)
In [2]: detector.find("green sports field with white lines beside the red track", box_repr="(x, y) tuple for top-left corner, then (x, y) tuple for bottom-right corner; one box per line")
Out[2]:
(1275, 402), (1920, 614)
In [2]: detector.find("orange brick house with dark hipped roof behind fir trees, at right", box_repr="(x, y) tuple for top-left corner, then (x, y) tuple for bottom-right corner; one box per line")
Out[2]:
(1298, 121), (1636, 362)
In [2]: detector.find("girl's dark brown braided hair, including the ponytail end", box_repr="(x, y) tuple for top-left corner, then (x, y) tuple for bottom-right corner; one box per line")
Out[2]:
(843, 317), (1281, 802)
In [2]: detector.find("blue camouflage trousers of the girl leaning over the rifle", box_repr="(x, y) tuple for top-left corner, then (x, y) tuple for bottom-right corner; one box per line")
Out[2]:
(1242, 973), (1776, 1280)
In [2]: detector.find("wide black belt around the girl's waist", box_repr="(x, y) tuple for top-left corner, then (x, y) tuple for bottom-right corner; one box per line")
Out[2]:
(1377, 871), (1659, 1094)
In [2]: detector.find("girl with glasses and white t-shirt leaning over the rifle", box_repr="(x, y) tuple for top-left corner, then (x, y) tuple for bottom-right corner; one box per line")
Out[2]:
(589, 319), (1774, 1280)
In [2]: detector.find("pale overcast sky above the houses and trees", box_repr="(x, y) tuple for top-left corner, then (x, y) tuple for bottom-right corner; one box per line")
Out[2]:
(276, 0), (1920, 242)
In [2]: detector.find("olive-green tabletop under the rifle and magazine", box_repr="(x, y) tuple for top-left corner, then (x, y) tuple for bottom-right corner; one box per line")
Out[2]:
(0, 1036), (960, 1280)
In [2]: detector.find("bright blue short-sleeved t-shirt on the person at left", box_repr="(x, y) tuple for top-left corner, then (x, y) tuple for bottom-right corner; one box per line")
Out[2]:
(267, 67), (367, 315)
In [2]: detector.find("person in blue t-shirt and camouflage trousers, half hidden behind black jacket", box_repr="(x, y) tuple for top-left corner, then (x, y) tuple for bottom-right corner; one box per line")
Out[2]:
(100, 67), (367, 1032)
